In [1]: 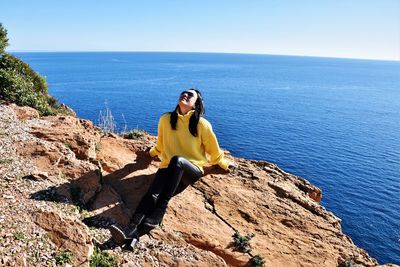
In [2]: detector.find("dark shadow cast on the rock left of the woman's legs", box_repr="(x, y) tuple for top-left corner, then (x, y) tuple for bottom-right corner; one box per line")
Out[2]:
(26, 151), (156, 227)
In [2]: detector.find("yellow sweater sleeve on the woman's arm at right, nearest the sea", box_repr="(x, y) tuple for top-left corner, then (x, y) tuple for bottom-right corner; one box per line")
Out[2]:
(202, 121), (229, 170)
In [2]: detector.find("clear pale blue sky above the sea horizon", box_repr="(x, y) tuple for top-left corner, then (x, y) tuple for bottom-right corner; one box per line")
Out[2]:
(0, 0), (400, 60)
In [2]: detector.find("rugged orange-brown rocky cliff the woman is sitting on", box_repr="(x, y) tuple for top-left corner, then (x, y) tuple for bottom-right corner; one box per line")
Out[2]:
(0, 105), (396, 266)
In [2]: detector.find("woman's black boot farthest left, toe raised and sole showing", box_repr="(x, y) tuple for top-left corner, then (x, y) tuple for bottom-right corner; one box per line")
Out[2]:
(109, 213), (145, 246)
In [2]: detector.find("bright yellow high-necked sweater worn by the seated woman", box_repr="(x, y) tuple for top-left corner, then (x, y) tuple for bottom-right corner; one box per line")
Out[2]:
(150, 111), (229, 170)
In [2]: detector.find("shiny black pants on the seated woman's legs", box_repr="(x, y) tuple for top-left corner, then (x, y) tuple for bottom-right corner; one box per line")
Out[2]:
(135, 156), (203, 220)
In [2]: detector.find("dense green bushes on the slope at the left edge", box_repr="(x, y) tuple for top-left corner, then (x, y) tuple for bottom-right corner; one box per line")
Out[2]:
(0, 23), (70, 116)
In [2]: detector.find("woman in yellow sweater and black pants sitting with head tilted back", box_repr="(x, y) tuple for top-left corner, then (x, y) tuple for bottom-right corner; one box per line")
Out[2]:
(110, 89), (234, 248)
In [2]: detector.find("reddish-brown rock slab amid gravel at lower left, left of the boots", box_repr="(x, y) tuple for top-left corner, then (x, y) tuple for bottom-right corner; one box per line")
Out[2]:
(34, 211), (93, 266)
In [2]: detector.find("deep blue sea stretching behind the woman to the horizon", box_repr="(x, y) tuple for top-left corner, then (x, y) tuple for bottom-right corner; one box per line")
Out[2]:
(13, 52), (400, 264)
